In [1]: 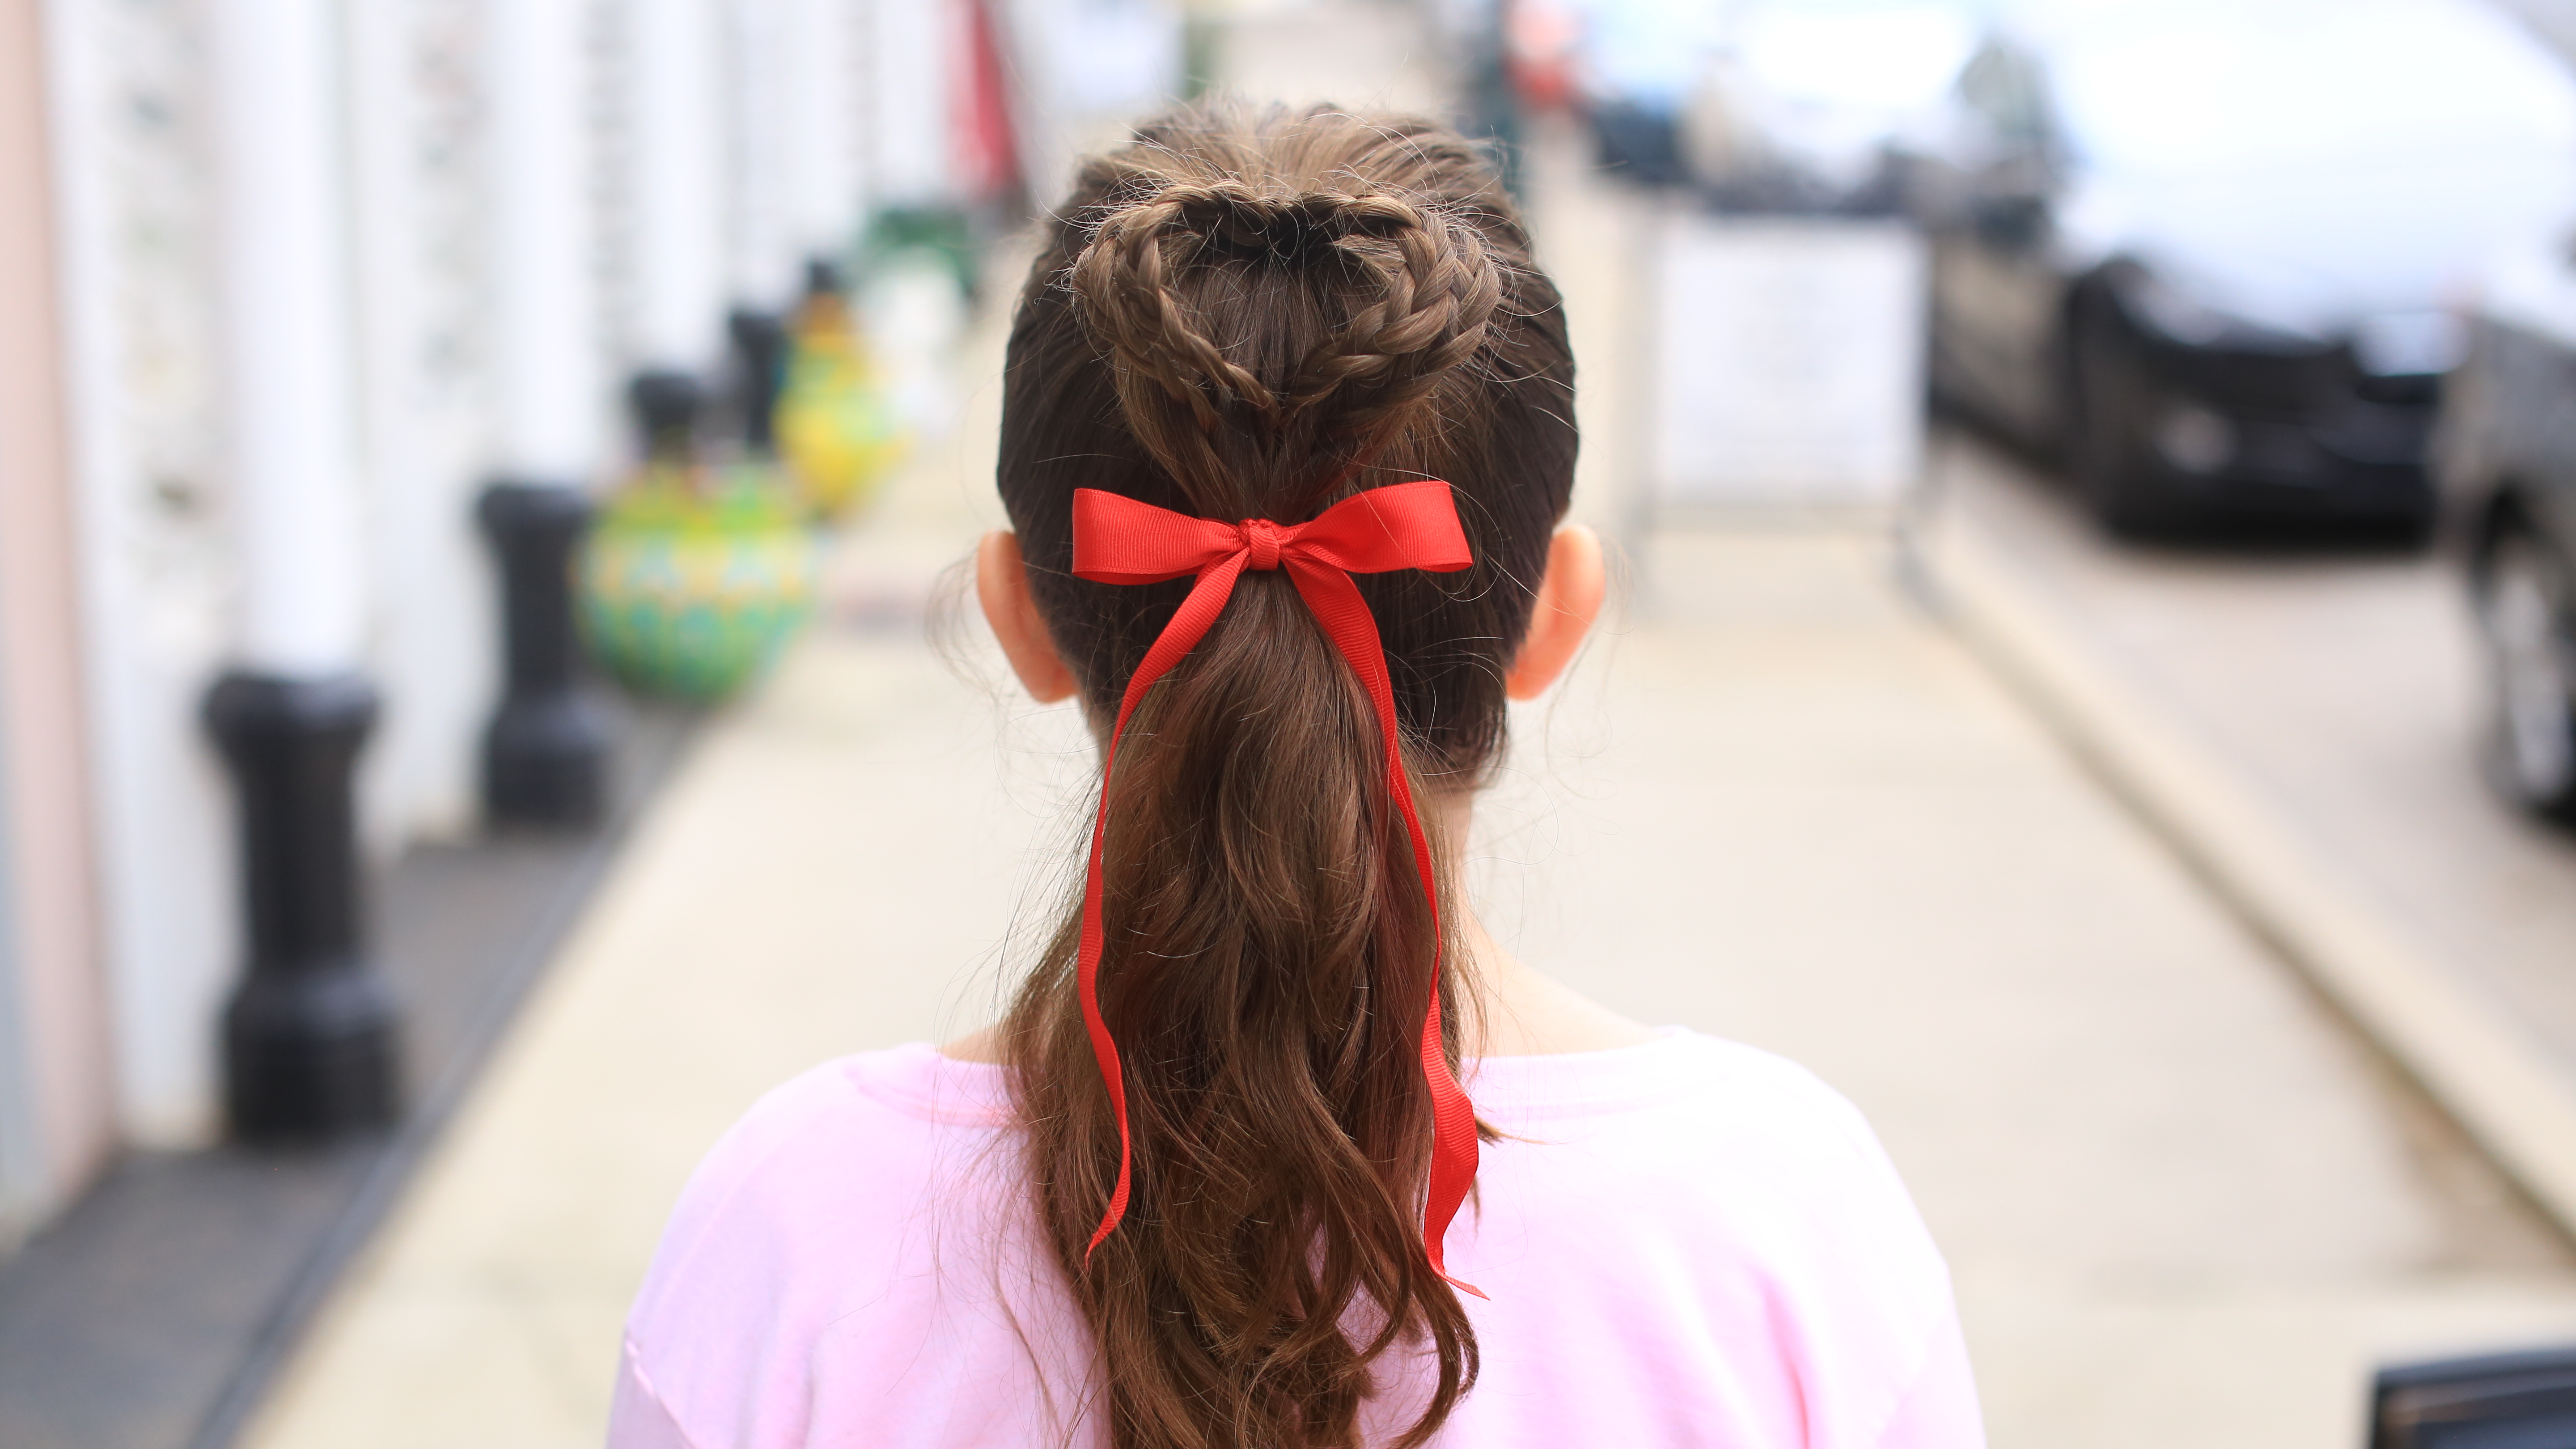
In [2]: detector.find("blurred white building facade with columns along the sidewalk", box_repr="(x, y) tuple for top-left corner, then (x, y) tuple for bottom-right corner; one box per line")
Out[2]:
(0, 0), (1025, 1250)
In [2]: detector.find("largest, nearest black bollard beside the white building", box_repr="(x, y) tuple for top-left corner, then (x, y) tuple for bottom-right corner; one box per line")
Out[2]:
(206, 673), (399, 1145)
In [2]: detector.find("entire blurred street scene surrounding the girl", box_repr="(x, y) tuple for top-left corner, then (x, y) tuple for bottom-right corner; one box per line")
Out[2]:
(0, 0), (2576, 1449)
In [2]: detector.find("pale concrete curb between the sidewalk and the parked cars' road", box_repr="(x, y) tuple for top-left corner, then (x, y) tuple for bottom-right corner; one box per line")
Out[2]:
(1901, 508), (2576, 1237)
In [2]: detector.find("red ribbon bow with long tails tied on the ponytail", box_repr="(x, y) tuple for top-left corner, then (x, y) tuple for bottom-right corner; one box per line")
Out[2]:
(1074, 479), (1484, 1297)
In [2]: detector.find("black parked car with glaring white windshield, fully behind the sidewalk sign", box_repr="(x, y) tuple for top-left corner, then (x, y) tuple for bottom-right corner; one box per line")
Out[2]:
(1909, 0), (2576, 531)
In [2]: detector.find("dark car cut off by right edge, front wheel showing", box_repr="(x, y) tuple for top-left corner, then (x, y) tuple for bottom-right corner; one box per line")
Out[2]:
(2434, 237), (2576, 825)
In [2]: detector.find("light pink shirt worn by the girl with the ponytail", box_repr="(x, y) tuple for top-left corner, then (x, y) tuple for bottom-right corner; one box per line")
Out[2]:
(608, 1031), (1983, 1449)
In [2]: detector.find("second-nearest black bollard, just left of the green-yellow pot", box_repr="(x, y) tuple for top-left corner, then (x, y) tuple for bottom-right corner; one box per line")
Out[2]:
(474, 482), (610, 830)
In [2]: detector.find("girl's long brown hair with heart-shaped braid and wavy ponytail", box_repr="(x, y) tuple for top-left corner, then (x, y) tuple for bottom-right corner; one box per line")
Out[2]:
(1000, 108), (1576, 1449)
